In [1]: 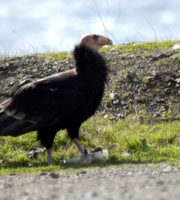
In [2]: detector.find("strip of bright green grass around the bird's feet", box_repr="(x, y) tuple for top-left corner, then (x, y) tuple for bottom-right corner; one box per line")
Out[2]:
(0, 115), (180, 174)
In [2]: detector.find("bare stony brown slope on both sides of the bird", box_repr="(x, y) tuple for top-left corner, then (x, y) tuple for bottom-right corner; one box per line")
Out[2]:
(0, 42), (180, 120)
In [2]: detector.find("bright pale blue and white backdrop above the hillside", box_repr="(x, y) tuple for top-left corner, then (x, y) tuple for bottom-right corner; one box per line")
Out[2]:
(0, 0), (180, 55)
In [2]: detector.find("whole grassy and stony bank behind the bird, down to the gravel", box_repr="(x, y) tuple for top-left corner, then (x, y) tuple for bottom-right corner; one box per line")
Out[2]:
(0, 41), (180, 174)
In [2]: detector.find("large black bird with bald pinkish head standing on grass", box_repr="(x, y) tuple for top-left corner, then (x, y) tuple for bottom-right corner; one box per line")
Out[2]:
(0, 34), (112, 164)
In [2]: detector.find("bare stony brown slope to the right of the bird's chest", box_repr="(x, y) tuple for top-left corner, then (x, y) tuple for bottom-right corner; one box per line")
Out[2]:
(103, 46), (180, 118)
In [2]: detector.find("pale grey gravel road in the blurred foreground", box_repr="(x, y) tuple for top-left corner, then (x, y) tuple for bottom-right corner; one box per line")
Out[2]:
(0, 165), (180, 200)
